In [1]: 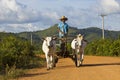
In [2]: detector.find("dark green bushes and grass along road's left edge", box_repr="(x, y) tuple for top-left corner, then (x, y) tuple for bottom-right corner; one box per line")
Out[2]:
(0, 35), (43, 79)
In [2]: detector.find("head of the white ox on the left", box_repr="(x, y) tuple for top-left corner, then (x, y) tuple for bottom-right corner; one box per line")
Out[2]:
(43, 37), (57, 48)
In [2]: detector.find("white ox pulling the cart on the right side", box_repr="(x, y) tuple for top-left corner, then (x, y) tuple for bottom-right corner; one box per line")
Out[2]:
(71, 34), (87, 67)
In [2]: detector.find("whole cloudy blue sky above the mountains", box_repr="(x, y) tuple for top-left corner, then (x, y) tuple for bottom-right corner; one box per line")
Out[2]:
(0, 0), (120, 33)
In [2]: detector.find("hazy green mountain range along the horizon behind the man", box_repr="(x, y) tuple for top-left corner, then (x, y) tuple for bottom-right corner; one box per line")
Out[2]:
(0, 24), (120, 43)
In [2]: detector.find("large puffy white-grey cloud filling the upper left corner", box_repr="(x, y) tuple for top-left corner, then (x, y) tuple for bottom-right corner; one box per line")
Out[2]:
(0, 0), (40, 24)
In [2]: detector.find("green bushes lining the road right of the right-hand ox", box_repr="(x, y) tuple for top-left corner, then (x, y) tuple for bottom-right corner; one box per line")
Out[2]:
(85, 39), (120, 56)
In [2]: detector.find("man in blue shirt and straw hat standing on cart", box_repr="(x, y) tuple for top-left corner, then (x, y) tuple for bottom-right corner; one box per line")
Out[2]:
(58, 16), (69, 56)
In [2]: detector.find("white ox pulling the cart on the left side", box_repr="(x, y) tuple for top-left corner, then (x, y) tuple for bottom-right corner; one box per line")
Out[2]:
(42, 37), (56, 70)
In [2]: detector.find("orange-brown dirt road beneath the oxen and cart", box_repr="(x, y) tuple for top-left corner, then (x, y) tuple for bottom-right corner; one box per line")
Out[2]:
(18, 56), (120, 80)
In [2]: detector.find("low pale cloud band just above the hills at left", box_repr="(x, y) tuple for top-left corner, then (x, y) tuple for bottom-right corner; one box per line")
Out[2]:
(0, 23), (41, 33)
